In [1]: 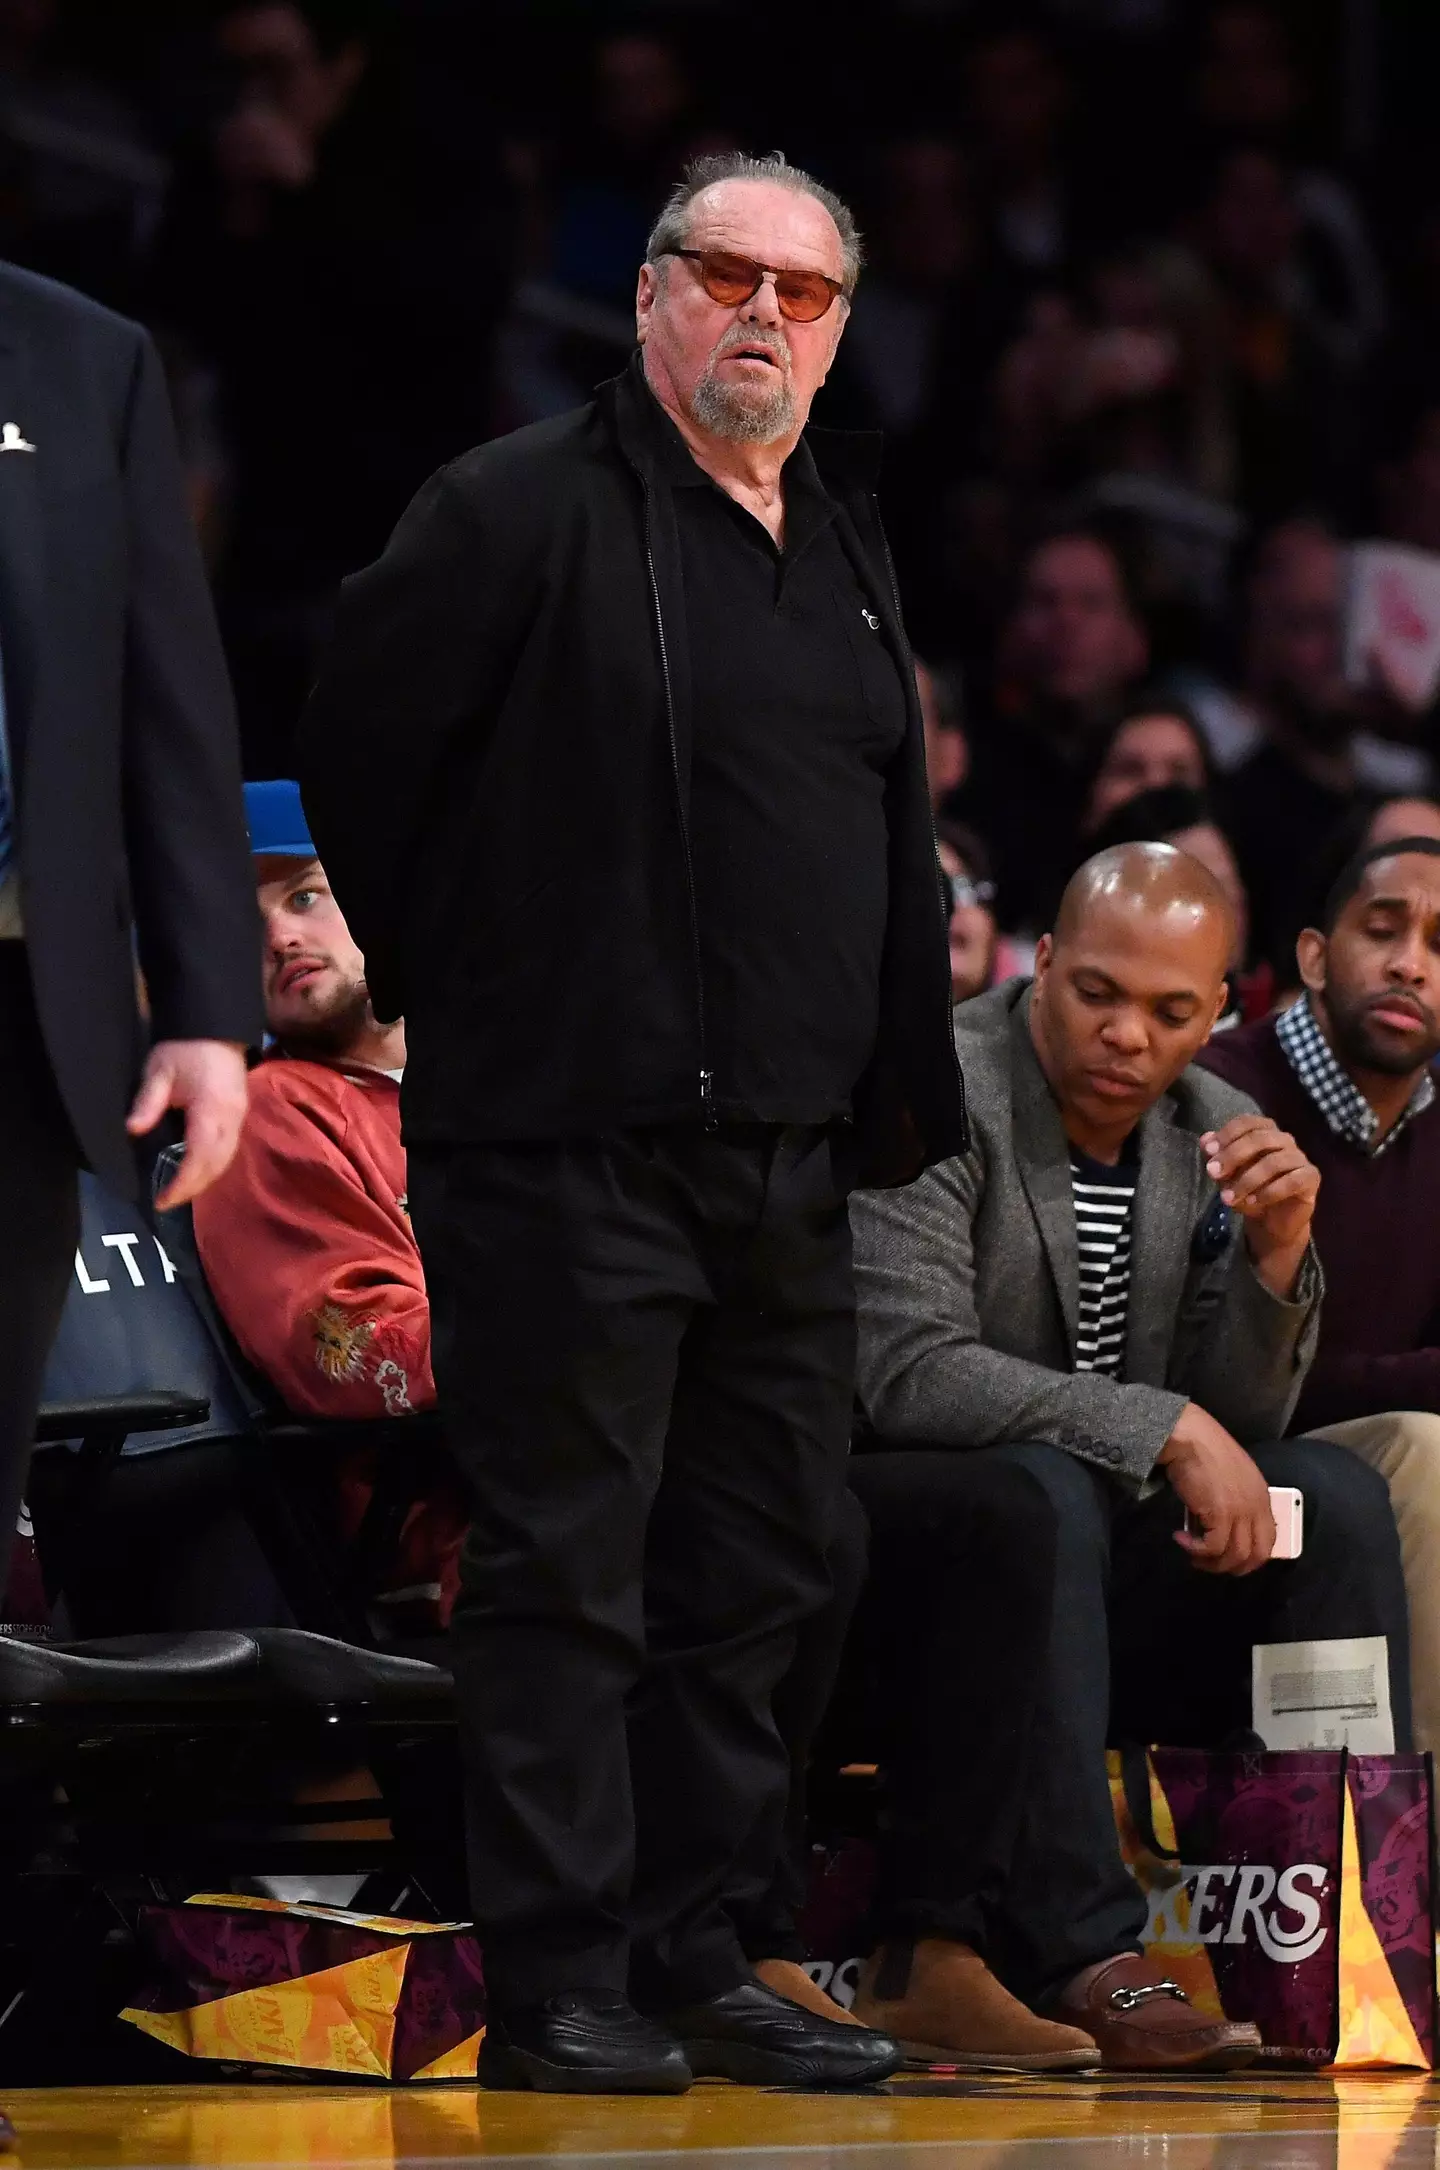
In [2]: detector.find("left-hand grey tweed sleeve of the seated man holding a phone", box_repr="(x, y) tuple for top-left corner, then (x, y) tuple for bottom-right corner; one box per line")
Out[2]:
(850, 1152), (1186, 1486)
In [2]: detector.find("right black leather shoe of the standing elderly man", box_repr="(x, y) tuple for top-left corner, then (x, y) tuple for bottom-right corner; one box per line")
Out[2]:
(661, 1981), (904, 2088)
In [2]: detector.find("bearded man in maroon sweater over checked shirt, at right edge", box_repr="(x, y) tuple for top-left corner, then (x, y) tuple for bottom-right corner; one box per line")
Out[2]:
(1199, 835), (1440, 1749)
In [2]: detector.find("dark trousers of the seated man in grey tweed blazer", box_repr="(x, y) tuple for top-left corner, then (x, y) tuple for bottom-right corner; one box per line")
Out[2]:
(846, 1439), (1410, 2005)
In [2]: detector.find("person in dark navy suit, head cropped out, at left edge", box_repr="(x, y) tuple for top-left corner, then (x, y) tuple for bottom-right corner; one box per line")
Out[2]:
(0, 265), (262, 1770)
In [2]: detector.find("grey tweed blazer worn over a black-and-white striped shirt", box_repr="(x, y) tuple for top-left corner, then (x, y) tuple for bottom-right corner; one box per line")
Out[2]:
(850, 979), (1323, 1486)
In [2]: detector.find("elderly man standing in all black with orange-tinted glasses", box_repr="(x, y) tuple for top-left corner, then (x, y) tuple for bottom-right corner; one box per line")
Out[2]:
(301, 154), (965, 2090)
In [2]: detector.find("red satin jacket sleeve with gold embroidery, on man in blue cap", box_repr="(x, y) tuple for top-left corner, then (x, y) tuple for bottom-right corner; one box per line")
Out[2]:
(195, 1068), (436, 1417)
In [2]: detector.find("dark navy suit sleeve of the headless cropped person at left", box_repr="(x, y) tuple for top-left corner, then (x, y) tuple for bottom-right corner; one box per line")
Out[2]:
(121, 334), (262, 1044)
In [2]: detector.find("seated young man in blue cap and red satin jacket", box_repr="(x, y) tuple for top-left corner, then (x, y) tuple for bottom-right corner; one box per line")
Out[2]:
(195, 783), (468, 1630)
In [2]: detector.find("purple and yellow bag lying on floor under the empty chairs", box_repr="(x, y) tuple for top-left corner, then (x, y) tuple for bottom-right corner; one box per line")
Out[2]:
(121, 1894), (486, 2081)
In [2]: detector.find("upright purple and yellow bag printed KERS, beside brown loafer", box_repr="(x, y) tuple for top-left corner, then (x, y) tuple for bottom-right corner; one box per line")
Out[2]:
(1110, 1749), (1436, 2068)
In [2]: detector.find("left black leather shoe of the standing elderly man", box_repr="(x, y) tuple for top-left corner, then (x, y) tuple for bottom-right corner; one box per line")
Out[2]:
(477, 1990), (694, 2094)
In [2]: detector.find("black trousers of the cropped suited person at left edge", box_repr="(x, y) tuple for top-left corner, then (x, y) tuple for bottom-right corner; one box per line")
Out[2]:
(0, 942), (80, 1601)
